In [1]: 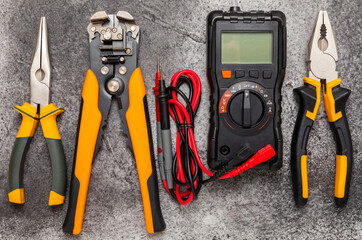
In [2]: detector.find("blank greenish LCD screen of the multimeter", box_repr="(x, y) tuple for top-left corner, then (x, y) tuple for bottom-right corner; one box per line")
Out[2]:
(221, 32), (273, 64)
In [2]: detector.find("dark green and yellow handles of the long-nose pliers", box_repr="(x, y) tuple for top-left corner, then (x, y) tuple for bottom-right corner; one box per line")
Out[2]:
(8, 103), (66, 205)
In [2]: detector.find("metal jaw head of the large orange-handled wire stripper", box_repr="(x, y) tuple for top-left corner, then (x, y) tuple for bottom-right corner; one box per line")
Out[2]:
(87, 11), (140, 151)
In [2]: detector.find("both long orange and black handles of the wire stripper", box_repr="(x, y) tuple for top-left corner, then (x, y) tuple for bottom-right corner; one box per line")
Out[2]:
(63, 68), (165, 234)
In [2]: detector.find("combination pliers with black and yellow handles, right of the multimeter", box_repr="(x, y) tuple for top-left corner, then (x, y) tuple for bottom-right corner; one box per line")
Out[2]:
(291, 11), (353, 206)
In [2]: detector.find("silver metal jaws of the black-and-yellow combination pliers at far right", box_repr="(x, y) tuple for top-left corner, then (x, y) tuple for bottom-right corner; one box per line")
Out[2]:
(307, 11), (338, 82)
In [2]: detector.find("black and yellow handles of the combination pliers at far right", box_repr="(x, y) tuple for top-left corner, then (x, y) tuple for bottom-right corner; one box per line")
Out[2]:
(291, 78), (353, 207)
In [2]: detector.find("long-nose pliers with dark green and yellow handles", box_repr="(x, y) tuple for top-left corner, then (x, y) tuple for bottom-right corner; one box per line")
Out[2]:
(8, 17), (67, 205)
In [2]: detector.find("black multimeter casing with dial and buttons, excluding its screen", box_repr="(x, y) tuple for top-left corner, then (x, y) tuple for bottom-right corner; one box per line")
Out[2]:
(207, 7), (286, 170)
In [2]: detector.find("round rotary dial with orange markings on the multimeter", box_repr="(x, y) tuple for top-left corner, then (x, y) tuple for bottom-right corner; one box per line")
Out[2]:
(219, 82), (274, 132)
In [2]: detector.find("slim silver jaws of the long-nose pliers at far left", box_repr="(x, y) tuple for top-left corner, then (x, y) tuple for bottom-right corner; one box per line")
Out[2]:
(30, 17), (51, 110)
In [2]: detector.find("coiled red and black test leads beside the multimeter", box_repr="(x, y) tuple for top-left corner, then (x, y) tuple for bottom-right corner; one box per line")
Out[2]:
(154, 63), (275, 205)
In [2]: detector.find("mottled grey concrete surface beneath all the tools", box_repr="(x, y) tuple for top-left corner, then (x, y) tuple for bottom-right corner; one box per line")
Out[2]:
(0, 0), (362, 239)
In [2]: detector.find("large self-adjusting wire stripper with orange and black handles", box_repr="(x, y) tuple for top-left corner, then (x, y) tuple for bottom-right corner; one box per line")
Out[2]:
(63, 11), (165, 234)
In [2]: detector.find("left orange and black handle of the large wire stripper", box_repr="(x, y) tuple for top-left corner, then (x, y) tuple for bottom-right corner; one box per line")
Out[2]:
(63, 70), (102, 234)
